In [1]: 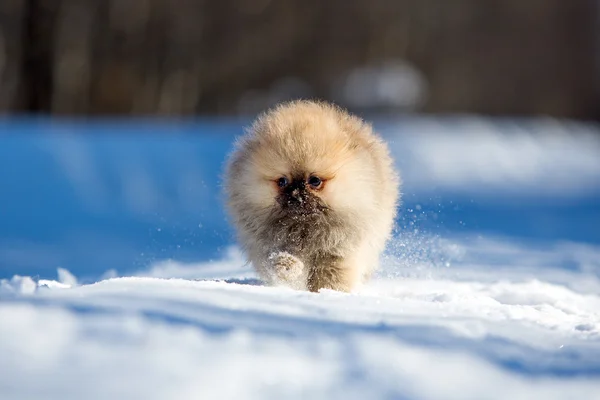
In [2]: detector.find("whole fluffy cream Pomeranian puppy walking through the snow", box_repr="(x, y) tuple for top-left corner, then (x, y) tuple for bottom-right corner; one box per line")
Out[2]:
(225, 101), (400, 292)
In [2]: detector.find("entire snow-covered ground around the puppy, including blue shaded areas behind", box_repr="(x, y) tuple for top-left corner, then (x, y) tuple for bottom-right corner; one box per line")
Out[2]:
(0, 119), (600, 400)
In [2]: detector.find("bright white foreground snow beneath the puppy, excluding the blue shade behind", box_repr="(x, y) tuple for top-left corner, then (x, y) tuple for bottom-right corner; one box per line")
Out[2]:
(0, 233), (600, 400)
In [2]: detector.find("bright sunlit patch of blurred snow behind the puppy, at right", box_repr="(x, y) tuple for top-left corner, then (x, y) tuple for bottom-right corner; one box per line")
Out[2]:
(380, 118), (600, 198)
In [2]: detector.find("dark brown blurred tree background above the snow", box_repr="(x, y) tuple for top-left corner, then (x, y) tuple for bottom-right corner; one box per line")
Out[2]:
(0, 0), (600, 120)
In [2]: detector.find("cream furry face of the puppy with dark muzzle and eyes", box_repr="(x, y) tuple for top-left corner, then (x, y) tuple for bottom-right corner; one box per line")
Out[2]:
(231, 106), (374, 222)
